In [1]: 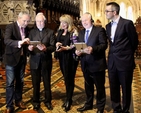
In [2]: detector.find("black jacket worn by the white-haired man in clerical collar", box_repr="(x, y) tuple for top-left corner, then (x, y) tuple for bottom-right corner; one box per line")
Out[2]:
(29, 28), (55, 69)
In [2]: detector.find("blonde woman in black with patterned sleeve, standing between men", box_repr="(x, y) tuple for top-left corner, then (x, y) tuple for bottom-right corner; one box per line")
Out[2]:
(56, 14), (78, 111)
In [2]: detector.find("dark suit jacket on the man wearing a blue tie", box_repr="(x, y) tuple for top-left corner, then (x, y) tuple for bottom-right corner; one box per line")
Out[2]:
(78, 26), (107, 73)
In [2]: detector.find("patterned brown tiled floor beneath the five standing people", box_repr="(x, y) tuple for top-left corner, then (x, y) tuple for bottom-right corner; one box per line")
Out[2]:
(0, 59), (141, 113)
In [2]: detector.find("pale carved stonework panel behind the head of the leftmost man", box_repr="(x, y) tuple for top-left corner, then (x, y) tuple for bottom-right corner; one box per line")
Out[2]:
(0, 0), (36, 25)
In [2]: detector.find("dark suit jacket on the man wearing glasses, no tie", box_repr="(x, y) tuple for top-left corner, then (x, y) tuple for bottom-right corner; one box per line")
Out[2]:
(106, 17), (138, 71)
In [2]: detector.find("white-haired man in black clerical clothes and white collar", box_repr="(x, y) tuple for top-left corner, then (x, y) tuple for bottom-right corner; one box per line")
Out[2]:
(28, 13), (55, 110)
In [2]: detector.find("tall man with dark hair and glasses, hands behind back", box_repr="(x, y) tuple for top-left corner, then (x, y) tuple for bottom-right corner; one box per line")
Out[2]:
(105, 2), (138, 113)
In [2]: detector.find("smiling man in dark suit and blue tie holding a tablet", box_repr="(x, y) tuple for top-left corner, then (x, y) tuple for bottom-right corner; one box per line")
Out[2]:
(76, 12), (107, 113)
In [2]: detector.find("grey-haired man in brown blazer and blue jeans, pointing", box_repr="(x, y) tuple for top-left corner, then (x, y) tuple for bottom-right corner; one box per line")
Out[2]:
(4, 11), (30, 113)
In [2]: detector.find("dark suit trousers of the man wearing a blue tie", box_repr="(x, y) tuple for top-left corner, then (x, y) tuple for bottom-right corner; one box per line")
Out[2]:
(84, 71), (106, 111)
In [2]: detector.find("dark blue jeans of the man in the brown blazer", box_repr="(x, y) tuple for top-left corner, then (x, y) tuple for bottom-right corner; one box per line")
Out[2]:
(5, 57), (25, 109)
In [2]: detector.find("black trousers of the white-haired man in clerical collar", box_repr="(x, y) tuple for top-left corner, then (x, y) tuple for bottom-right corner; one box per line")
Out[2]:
(31, 67), (52, 105)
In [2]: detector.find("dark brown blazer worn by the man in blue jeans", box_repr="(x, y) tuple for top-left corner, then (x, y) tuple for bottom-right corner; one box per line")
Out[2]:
(4, 22), (28, 66)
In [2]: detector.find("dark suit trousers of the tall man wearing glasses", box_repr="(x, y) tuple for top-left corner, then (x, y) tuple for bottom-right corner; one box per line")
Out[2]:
(108, 66), (133, 112)
